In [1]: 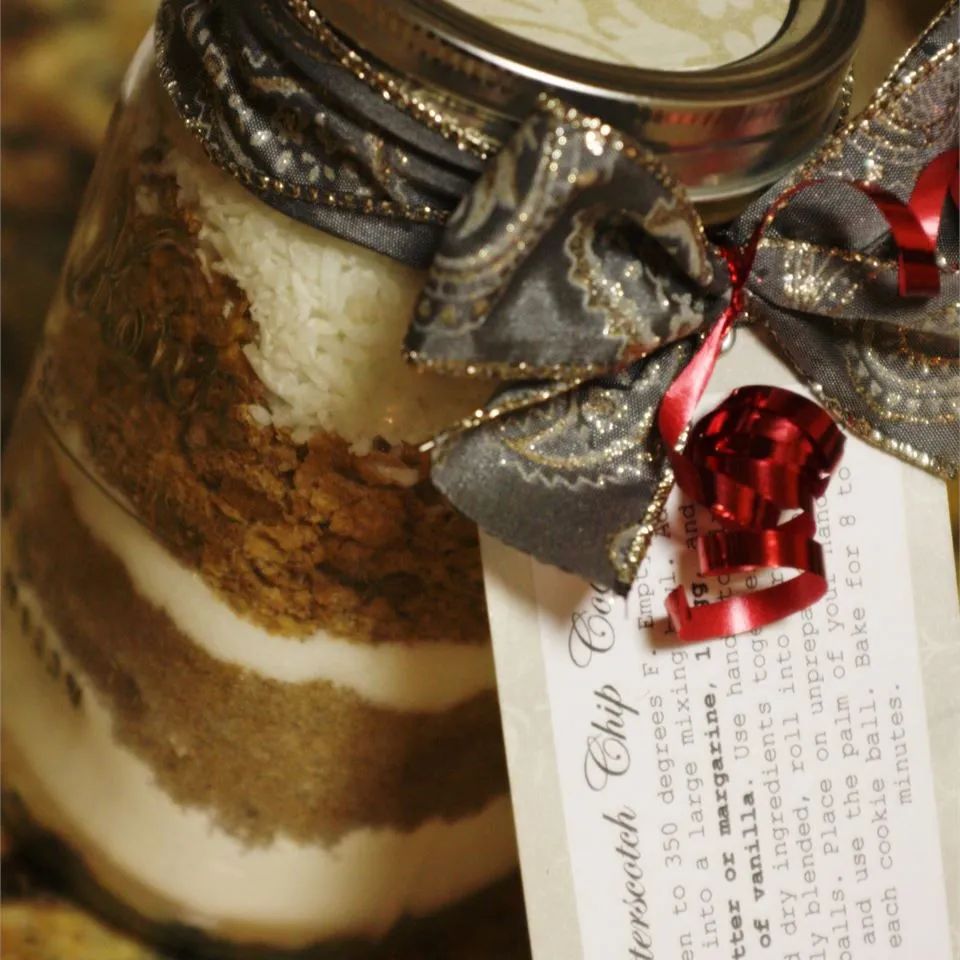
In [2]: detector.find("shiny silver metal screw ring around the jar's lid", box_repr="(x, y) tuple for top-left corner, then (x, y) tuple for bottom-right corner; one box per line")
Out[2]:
(306, 0), (865, 202)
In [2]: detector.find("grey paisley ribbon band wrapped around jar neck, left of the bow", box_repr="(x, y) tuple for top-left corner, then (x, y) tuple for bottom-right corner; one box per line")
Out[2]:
(156, 0), (488, 266)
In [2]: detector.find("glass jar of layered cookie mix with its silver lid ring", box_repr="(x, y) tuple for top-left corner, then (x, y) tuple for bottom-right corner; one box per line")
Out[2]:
(3, 0), (862, 957)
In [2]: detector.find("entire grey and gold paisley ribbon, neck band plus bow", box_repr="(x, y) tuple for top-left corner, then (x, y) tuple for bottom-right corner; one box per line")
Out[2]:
(160, 0), (960, 586)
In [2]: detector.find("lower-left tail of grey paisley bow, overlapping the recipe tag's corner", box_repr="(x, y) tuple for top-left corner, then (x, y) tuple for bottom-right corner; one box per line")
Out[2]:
(431, 340), (693, 584)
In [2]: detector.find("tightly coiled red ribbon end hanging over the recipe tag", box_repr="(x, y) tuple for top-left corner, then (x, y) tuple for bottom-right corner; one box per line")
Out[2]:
(666, 387), (843, 641)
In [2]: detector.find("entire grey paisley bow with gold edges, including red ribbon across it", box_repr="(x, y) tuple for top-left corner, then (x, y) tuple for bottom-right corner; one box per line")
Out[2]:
(406, 5), (960, 632)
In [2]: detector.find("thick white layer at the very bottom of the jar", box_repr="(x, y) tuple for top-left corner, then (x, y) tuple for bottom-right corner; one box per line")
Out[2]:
(2, 568), (516, 947)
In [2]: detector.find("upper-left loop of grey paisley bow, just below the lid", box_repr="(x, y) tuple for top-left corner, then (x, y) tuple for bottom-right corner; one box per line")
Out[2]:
(407, 100), (727, 377)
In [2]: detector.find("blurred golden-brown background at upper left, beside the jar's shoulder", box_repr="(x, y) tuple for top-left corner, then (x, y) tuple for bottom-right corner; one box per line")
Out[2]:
(0, 0), (156, 438)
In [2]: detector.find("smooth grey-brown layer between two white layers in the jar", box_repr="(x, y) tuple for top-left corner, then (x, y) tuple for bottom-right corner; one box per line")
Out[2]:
(7, 411), (507, 842)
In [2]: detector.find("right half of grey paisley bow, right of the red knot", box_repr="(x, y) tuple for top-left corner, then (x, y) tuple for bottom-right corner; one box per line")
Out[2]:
(733, 4), (960, 475)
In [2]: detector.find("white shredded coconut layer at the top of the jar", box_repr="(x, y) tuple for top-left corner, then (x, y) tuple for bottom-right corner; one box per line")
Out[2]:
(164, 107), (491, 453)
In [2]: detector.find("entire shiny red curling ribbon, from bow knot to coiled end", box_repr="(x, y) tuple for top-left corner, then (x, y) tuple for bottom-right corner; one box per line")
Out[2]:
(657, 149), (960, 641)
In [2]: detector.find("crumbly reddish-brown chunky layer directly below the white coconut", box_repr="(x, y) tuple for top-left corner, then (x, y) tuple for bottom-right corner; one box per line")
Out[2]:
(39, 131), (487, 643)
